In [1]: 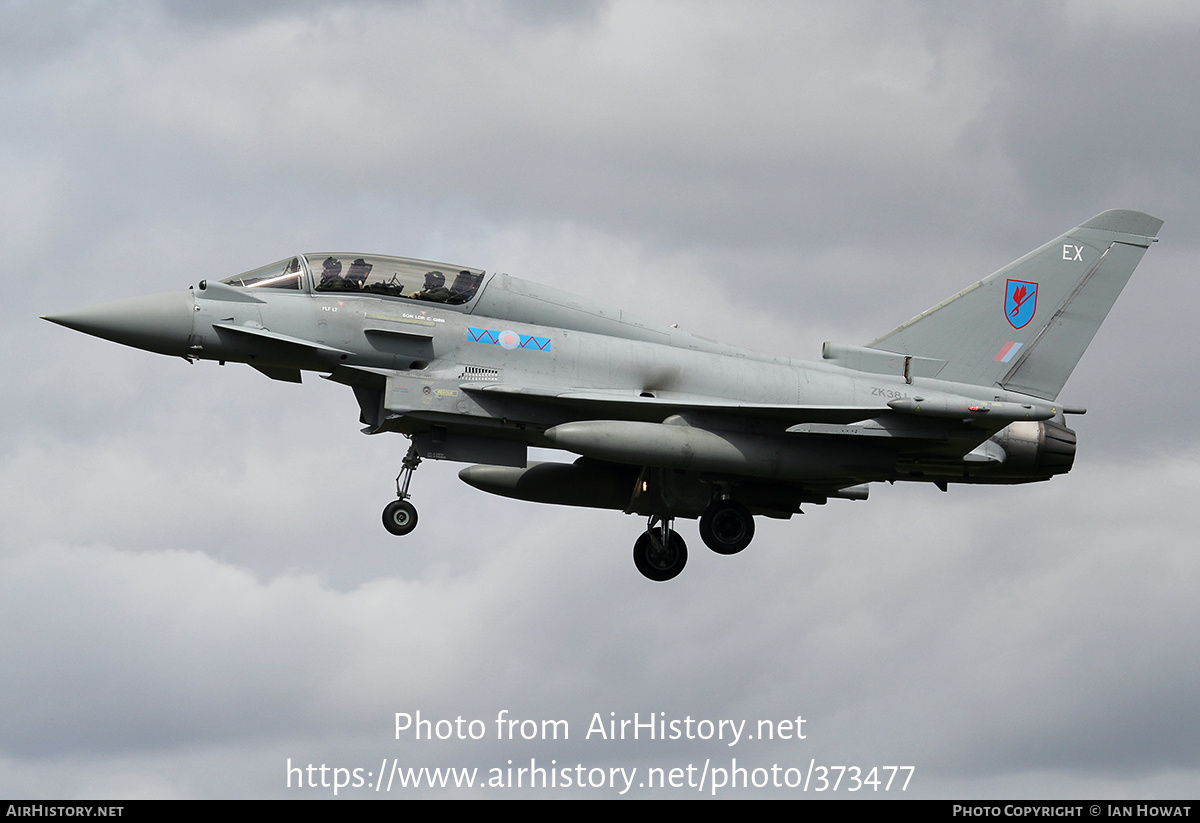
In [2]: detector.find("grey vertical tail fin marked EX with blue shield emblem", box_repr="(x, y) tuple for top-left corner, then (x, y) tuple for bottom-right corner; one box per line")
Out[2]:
(868, 209), (1163, 400)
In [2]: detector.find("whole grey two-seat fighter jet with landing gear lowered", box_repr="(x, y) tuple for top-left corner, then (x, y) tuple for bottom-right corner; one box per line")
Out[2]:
(46, 210), (1162, 581)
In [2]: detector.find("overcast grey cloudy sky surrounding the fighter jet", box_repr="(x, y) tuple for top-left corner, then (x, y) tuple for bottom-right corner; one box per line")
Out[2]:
(0, 0), (1200, 798)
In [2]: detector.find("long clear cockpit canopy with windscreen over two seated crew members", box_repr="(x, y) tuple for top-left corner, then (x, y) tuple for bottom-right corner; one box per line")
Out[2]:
(221, 253), (484, 306)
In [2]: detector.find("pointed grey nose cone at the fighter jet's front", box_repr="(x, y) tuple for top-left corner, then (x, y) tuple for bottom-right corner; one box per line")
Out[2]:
(42, 292), (196, 355)
